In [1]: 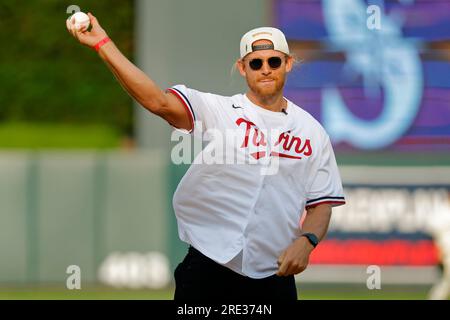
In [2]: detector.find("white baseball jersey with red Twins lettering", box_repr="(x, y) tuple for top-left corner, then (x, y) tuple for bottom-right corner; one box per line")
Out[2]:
(168, 85), (345, 278)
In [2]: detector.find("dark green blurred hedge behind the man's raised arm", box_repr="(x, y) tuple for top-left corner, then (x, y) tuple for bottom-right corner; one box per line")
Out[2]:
(0, 0), (134, 133)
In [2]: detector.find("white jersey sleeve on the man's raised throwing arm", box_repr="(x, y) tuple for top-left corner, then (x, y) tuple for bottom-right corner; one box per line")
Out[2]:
(166, 85), (216, 135)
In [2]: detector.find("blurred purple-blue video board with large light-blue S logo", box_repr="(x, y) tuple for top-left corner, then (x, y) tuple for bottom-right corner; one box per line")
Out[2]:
(274, 0), (450, 152)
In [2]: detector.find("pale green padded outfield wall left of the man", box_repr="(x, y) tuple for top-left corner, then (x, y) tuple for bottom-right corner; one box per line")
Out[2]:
(0, 151), (170, 284)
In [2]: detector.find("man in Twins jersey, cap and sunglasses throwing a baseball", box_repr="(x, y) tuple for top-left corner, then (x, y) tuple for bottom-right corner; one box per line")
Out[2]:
(67, 14), (345, 301)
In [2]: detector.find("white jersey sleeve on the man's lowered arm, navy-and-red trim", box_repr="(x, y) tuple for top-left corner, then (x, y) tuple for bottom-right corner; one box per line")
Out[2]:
(305, 135), (345, 209)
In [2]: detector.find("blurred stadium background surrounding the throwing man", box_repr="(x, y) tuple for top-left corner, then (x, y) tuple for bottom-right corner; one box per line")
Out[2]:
(0, 0), (450, 299)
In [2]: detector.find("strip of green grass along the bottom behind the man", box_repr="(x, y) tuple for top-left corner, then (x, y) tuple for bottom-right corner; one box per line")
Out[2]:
(0, 284), (429, 300)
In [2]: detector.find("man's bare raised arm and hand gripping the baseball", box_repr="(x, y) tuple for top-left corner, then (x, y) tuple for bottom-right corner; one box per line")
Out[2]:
(66, 13), (192, 130)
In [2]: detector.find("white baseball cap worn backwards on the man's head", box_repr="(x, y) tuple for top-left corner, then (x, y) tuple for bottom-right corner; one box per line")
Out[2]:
(240, 27), (289, 59)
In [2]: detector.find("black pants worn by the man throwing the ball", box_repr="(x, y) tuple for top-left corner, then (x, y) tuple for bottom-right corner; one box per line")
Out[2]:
(174, 247), (297, 302)
